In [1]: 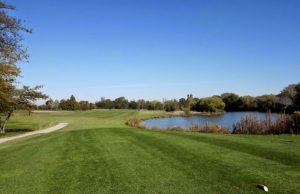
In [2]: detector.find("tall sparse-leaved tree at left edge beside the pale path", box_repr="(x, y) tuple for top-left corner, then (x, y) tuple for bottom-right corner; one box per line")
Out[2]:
(0, 1), (37, 133)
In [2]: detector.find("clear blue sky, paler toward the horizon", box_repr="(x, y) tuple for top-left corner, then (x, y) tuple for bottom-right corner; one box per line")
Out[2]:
(6, 0), (300, 101)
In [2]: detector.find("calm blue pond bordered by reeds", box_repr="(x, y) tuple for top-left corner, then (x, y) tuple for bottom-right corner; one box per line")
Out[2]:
(142, 112), (277, 130)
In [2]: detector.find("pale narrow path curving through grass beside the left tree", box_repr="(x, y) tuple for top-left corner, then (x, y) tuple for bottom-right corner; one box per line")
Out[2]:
(0, 123), (68, 143)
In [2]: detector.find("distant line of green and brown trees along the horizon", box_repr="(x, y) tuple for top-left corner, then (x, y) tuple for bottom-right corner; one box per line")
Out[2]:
(38, 83), (300, 113)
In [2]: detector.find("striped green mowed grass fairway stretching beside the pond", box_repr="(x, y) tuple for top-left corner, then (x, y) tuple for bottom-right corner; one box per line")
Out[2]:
(0, 110), (300, 193)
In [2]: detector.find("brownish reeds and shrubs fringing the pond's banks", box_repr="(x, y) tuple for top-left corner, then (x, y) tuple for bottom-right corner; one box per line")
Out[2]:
(126, 112), (300, 135)
